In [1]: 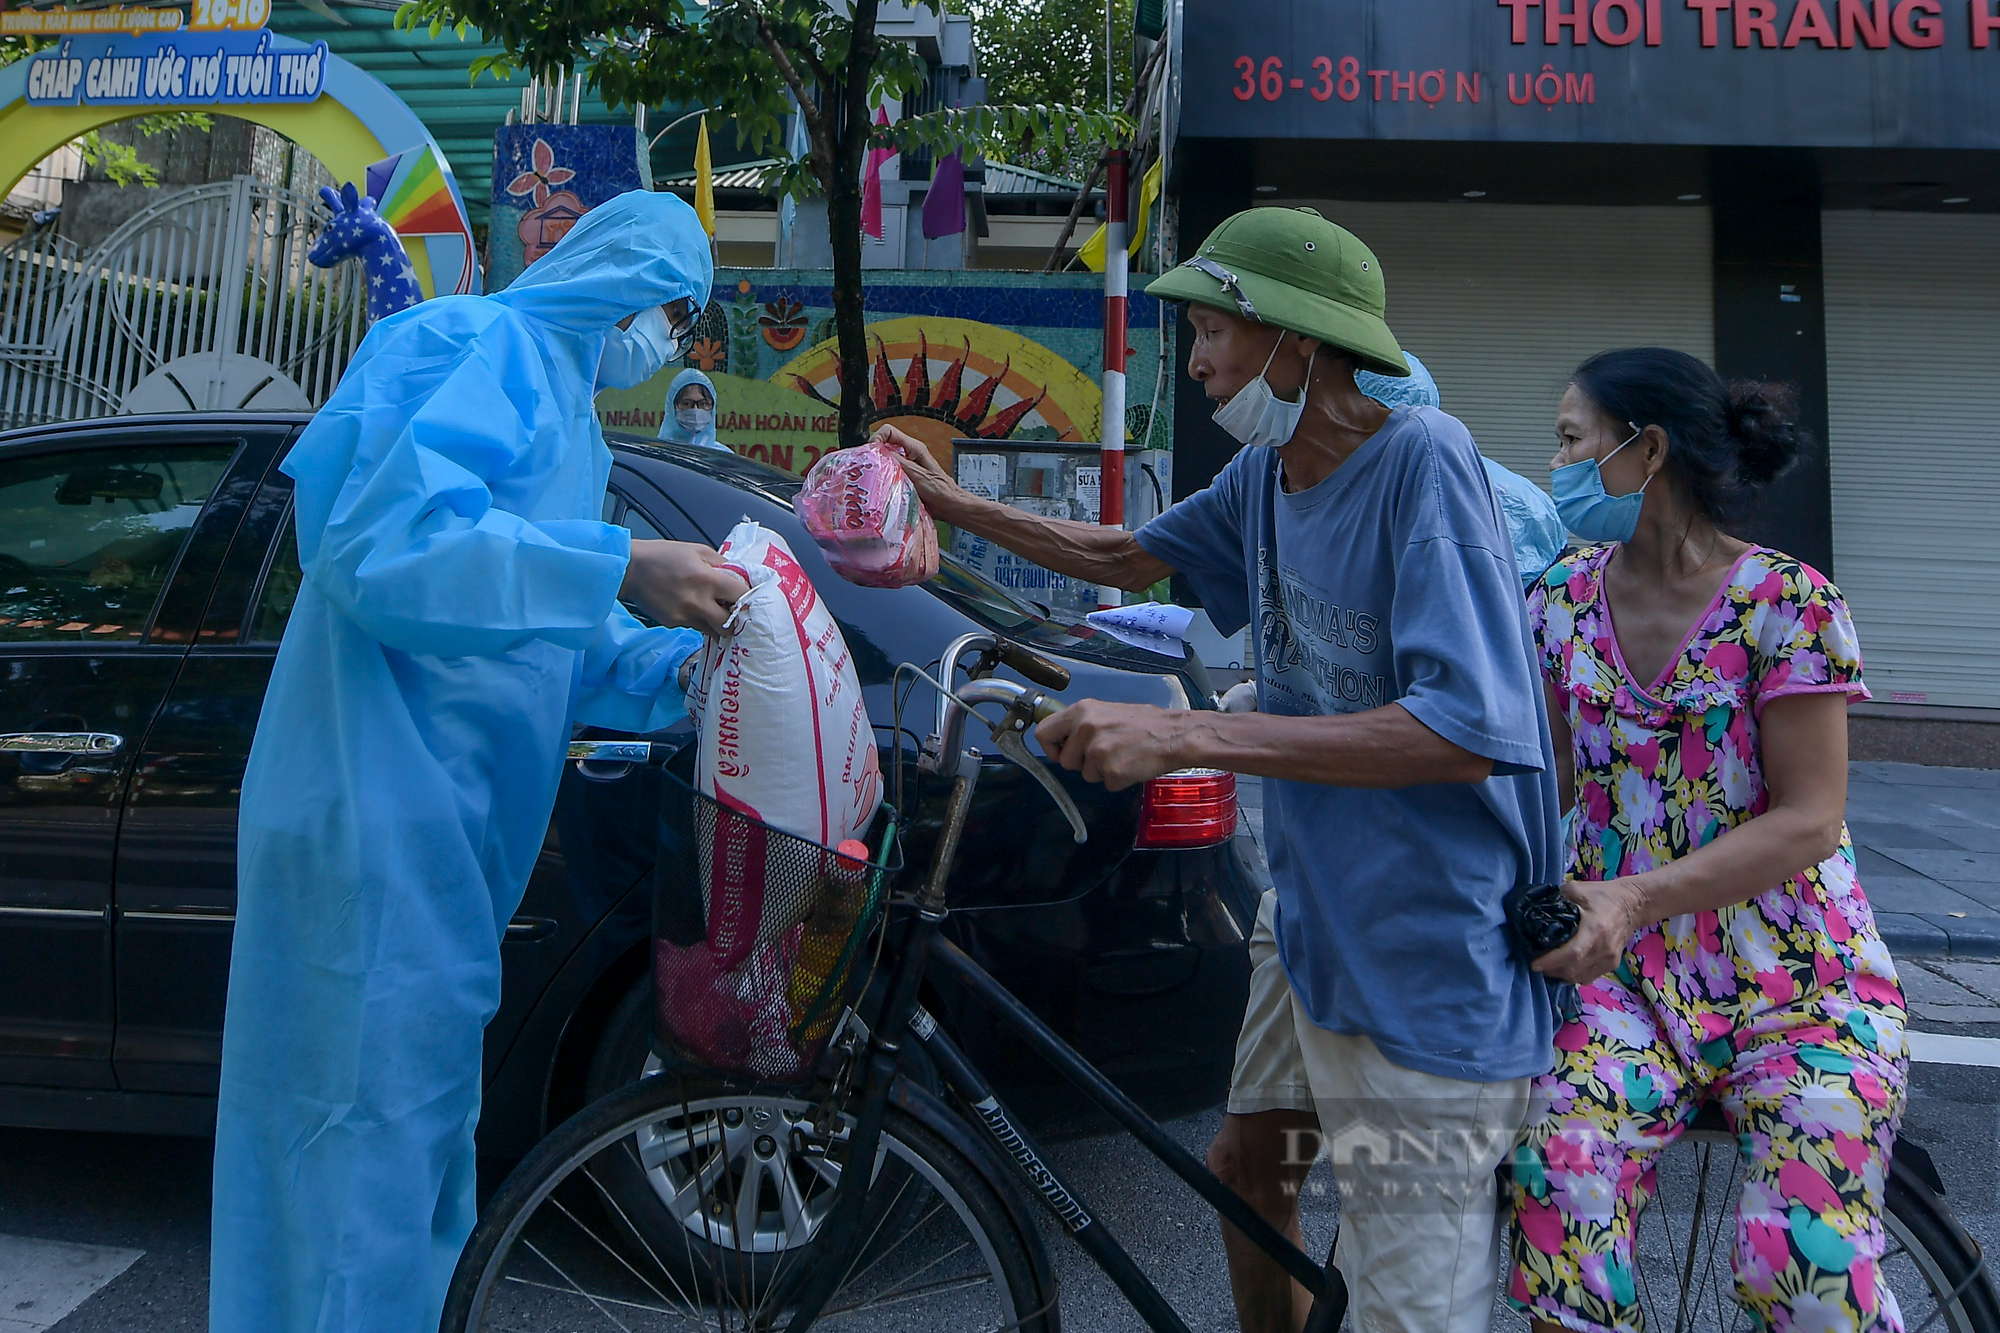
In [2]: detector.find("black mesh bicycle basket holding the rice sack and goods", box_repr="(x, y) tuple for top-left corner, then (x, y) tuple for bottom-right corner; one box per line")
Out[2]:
(652, 777), (902, 1083)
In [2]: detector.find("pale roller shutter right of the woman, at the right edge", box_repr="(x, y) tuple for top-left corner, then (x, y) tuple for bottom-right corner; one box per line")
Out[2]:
(1822, 212), (2000, 709)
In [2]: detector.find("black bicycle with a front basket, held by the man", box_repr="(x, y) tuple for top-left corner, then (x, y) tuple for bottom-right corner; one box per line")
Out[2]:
(442, 634), (2000, 1333)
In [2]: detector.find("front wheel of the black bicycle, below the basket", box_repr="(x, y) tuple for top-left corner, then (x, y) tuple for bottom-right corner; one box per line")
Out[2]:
(442, 1075), (1058, 1333)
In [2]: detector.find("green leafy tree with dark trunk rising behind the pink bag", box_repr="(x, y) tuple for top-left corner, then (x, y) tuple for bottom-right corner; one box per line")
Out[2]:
(396, 0), (1120, 444)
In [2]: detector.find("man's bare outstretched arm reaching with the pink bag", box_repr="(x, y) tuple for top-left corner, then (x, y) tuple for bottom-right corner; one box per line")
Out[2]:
(874, 426), (1174, 590)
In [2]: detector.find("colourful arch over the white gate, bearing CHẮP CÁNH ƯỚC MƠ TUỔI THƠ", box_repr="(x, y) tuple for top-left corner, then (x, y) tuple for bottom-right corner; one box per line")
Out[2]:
(0, 32), (480, 298)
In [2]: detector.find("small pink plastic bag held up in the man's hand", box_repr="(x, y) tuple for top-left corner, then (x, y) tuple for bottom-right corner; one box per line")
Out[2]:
(792, 440), (938, 588)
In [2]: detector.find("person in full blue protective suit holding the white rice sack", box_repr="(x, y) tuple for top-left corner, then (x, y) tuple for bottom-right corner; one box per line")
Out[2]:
(208, 192), (746, 1333)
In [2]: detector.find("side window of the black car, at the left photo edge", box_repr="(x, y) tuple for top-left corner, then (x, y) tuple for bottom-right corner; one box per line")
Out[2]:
(0, 444), (236, 642)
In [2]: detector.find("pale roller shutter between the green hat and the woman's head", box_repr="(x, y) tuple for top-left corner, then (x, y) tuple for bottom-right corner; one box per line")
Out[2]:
(1312, 202), (1716, 486)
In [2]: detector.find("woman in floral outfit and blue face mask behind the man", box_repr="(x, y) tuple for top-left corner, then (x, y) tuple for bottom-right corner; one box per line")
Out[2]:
(1508, 348), (1908, 1333)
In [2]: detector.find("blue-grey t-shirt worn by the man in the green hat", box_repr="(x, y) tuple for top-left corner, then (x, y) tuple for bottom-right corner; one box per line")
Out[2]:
(1138, 408), (1562, 1083)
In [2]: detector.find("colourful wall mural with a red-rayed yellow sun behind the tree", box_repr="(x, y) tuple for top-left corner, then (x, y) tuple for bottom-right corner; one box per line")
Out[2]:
(600, 266), (1174, 472)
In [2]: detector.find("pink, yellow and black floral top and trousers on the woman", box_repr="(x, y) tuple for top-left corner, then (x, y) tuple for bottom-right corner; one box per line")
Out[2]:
(1508, 546), (1908, 1333)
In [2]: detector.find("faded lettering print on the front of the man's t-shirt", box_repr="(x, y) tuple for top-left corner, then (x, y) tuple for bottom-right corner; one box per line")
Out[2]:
(1256, 546), (1396, 717)
